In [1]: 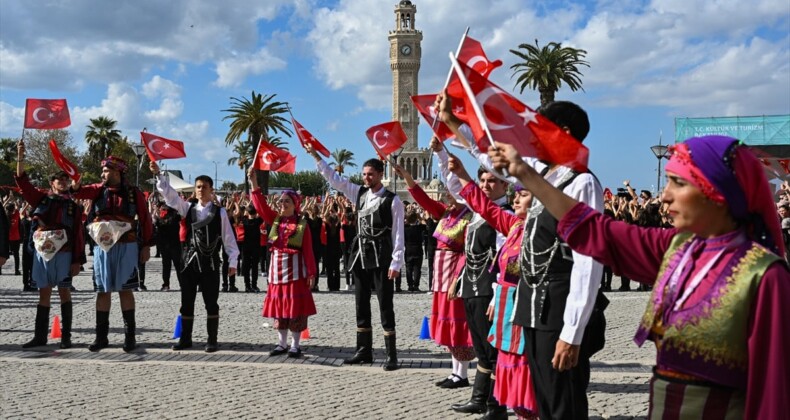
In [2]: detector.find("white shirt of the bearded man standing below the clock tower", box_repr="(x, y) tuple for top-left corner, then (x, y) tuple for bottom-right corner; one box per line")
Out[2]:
(316, 159), (406, 271)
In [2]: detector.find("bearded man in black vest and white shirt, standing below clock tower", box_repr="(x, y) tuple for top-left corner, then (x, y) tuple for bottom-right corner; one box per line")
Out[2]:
(305, 143), (405, 371)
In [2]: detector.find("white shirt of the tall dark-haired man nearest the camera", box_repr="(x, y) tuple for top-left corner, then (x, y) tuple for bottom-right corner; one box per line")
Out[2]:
(462, 125), (603, 345)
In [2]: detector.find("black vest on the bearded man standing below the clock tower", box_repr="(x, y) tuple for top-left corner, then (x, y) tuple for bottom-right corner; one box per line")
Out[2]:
(350, 187), (395, 269)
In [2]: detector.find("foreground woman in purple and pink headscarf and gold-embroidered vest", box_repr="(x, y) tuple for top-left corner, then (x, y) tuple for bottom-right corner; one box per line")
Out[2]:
(489, 136), (790, 419)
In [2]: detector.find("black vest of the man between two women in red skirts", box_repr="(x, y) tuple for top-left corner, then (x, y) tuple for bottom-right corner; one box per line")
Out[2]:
(458, 204), (513, 299)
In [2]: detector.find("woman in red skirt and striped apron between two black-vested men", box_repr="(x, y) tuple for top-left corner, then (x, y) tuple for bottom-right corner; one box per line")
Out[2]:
(249, 168), (318, 357)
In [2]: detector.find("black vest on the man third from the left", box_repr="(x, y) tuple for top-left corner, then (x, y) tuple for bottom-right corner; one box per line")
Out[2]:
(183, 203), (222, 272)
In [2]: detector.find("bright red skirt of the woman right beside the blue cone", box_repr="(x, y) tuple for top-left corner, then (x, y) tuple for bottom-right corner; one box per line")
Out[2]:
(430, 292), (472, 347)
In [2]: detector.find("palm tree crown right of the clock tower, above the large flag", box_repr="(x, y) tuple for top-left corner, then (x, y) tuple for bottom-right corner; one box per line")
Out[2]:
(510, 39), (590, 106)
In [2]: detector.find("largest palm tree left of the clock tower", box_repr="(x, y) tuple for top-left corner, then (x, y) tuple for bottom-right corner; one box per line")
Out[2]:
(222, 91), (291, 194)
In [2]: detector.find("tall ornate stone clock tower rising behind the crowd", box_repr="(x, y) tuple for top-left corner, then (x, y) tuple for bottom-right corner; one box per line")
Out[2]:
(383, 0), (437, 201)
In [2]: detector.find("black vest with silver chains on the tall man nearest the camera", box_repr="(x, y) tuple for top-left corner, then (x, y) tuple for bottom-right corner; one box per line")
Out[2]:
(513, 171), (579, 331)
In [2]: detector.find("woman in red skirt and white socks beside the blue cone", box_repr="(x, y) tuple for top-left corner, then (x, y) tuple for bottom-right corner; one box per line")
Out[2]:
(393, 160), (475, 389)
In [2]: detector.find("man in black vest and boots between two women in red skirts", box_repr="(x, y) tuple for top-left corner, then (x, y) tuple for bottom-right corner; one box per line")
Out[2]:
(438, 149), (513, 418)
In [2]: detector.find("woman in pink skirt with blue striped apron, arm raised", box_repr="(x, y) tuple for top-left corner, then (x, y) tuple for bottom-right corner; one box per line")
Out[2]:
(449, 157), (538, 418)
